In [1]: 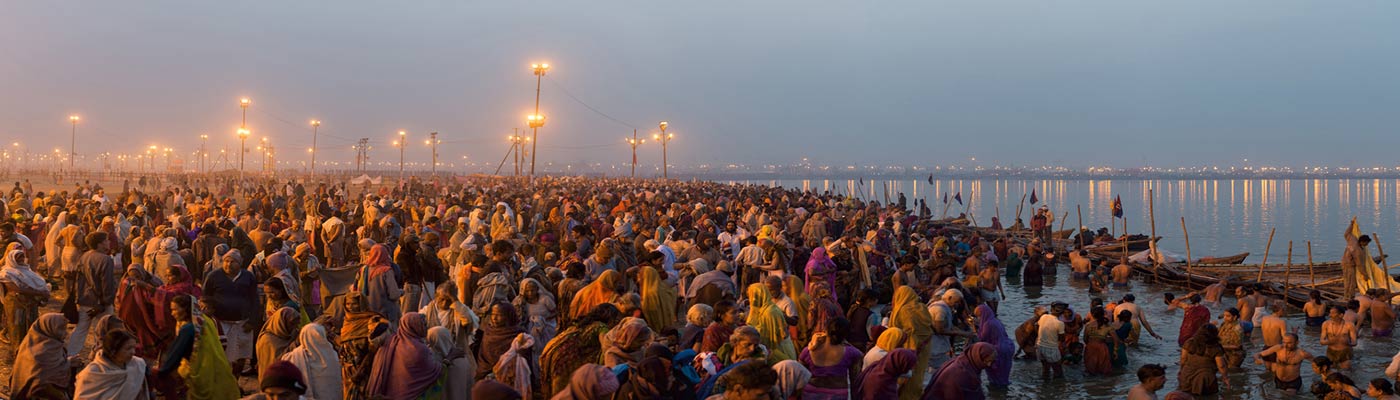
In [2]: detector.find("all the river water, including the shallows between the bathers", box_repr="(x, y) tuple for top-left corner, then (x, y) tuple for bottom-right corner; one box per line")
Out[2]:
(736, 179), (1400, 400)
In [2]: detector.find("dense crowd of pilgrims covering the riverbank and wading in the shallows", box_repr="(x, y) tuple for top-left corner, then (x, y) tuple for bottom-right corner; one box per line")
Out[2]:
(0, 178), (1400, 400)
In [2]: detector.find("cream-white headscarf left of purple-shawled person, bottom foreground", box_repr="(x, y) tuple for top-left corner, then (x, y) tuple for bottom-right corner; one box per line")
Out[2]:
(281, 323), (344, 400)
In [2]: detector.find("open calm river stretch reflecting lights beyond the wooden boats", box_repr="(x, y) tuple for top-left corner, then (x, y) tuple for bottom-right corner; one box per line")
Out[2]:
(736, 179), (1400, 264)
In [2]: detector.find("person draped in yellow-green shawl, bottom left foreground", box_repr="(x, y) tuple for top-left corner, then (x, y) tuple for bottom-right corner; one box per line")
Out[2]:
(154, 297), (239, 400)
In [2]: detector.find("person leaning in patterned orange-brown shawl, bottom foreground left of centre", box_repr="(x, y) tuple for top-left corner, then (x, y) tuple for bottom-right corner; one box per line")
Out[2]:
(539, 303), (622, 396)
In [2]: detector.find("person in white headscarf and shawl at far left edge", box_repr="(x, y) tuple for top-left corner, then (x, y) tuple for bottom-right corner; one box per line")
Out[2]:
(0, 250), (50, 359)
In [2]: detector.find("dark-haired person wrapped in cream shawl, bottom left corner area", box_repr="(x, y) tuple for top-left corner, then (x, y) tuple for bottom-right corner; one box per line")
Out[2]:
(74, 330), (148, 400)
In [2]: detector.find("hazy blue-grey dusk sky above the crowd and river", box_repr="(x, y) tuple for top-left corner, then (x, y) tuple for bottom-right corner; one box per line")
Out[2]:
(0, 0), (1400, 168)
